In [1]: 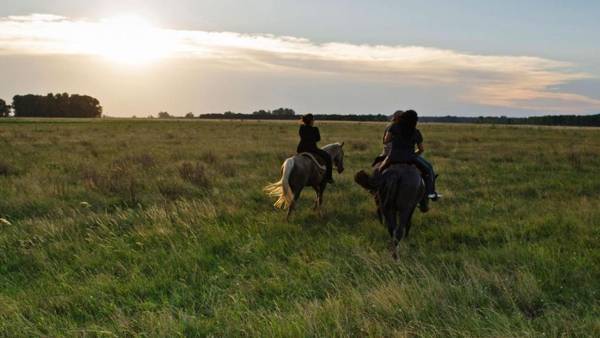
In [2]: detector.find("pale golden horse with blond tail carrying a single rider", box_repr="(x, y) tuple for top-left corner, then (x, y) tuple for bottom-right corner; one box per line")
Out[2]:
(264, 143), (344, 220)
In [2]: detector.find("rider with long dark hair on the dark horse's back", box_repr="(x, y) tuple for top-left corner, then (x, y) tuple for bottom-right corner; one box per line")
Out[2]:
(380, 110), (438, 201)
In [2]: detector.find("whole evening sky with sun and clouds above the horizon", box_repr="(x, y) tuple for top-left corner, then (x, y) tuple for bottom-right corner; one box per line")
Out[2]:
(0, 0), (600, 116)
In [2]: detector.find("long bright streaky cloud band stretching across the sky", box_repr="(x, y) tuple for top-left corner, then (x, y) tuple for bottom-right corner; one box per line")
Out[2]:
(0, 14), (600, 112)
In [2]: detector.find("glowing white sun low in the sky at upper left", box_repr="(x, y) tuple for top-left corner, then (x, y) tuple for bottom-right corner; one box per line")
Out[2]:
(93, 15), (168, 65)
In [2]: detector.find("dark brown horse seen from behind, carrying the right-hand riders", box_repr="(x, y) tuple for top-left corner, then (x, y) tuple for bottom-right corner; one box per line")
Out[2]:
(355, 164), (426, 258)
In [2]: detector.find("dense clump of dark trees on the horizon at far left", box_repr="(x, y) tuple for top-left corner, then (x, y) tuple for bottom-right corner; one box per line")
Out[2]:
(0, 93), (102, 118)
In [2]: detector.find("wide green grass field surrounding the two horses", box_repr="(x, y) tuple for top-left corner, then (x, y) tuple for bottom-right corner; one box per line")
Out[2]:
(0, 120), (600, 337)
